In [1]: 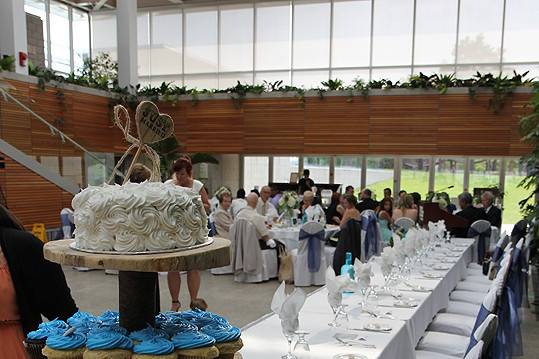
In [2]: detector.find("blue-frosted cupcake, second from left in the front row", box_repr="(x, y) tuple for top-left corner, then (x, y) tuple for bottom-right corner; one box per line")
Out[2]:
(83, 328), (133, 359)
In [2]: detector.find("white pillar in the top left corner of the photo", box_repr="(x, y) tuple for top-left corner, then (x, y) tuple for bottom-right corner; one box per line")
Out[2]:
(0, 0), (28, 75)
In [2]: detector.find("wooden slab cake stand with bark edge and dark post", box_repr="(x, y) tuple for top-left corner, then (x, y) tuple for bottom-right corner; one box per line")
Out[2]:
(43, 237), (230, 331)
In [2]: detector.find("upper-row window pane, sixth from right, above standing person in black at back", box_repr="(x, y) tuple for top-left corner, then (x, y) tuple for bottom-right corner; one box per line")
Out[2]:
(293, 1), (331, 69)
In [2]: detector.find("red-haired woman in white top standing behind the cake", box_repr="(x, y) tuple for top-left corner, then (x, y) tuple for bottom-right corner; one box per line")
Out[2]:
(167, 155), (210, 311)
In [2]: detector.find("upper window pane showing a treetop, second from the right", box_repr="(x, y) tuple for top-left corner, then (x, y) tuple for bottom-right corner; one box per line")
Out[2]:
(457, 0), (504, 64)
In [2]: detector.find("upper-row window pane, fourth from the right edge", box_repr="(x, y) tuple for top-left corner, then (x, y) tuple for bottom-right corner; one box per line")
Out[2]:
(372, 0), (414, 66)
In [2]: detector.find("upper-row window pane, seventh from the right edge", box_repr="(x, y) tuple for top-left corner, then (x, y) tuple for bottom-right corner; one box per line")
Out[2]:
(255, 2), (290, 70)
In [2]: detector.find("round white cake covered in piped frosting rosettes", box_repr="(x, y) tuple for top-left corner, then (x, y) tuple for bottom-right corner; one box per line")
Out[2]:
(72, 182), (208, 252)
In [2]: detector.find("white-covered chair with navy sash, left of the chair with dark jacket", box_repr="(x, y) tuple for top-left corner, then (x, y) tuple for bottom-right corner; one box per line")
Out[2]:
(291, 222), (329, 287)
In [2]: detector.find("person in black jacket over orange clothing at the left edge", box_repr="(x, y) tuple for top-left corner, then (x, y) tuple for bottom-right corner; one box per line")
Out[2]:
(0, 205), (77, 359)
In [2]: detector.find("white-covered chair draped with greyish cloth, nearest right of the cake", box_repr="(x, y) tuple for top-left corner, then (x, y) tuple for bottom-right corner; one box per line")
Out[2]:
(230, 219), (278, 283)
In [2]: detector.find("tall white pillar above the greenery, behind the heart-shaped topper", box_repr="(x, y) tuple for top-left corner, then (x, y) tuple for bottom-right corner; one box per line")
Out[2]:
(116, 0), (138, 87)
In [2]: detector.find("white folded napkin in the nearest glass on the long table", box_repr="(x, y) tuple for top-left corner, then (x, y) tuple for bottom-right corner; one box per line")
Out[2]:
(271, 281), (307, 334)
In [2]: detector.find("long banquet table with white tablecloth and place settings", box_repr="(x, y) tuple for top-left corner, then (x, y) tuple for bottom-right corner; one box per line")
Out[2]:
(241, 238), (473, 359)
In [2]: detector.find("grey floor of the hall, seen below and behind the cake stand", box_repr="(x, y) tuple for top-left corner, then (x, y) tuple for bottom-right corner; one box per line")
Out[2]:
(64, 267), (539, 359)
